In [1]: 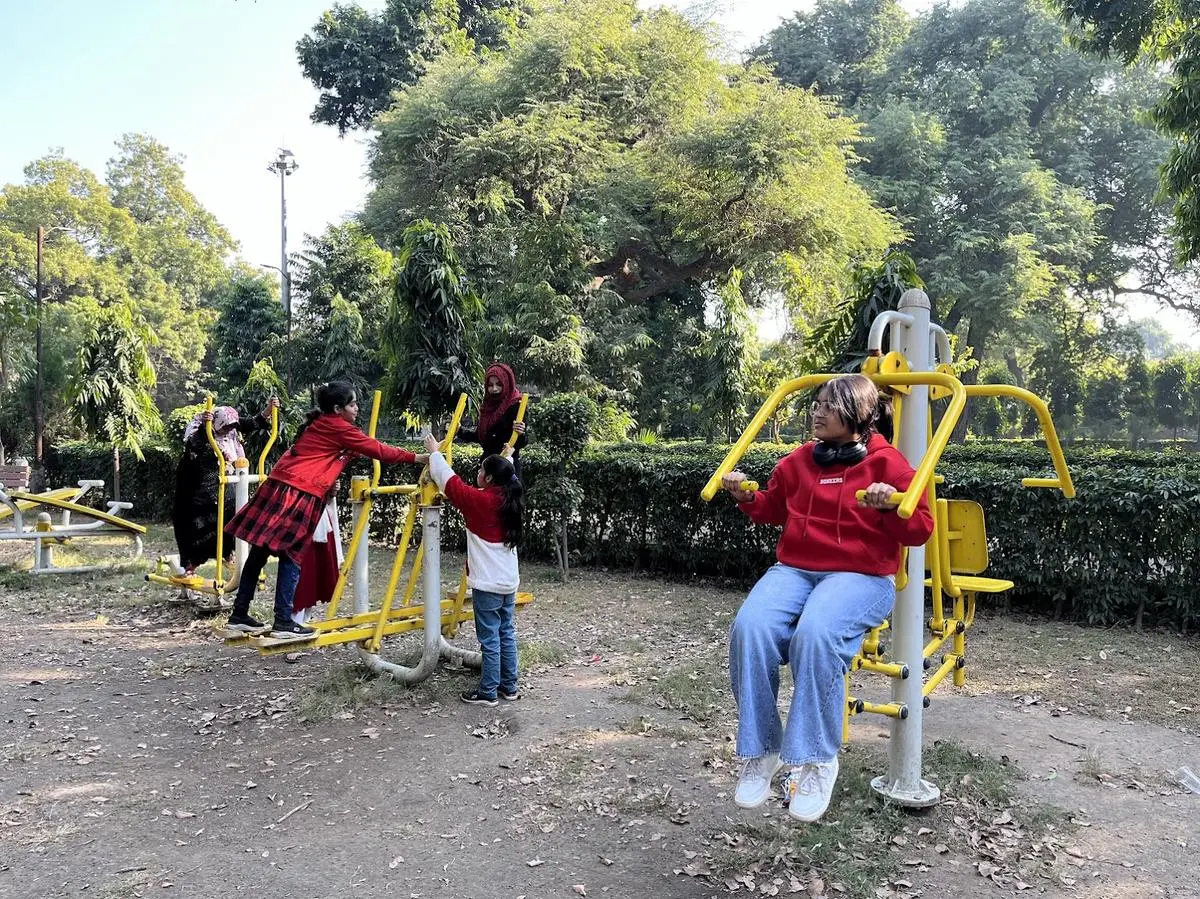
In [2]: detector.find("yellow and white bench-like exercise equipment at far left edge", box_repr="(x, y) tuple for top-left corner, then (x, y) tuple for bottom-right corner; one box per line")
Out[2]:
(0, 480), (146, 575)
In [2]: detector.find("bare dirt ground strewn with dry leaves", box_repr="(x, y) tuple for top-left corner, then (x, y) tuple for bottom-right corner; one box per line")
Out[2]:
(0, 532), (1200, 899)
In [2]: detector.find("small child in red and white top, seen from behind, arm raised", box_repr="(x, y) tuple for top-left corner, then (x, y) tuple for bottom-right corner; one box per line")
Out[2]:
(425, 434), (524, 706)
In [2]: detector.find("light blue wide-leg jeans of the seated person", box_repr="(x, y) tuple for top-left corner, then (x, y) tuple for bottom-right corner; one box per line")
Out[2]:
(730, 564), (895, 765)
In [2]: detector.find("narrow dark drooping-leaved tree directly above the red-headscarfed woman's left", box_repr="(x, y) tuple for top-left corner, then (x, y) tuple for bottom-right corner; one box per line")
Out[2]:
(383, 221), (484, 431)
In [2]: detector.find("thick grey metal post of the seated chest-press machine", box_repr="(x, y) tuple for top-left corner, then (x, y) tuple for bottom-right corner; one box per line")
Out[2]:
(871, 289), (941, 808)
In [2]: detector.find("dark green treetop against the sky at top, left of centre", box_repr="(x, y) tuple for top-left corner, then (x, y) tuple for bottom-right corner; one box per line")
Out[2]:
(296, 0), (523, 136)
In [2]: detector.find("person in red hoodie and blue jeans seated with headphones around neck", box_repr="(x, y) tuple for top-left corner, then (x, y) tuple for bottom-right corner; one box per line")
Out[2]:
(722, 374), (934, 821)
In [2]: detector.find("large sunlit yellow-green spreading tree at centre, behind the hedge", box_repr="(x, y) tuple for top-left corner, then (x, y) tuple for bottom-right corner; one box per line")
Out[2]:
(364, 0), (899, 418)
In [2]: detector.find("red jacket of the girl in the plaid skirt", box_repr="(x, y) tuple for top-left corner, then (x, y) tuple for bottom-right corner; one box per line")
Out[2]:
(269, 412), (416, 497)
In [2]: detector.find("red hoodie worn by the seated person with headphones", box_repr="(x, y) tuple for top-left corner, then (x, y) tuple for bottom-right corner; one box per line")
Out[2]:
(739, 434), (934, 575)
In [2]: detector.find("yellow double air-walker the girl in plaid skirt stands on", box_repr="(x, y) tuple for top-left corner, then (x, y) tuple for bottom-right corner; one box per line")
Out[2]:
(220, 391), (533, 684)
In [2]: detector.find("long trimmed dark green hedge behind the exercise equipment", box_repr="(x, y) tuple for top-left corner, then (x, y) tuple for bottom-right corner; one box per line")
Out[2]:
(39, 442), (1200, 628)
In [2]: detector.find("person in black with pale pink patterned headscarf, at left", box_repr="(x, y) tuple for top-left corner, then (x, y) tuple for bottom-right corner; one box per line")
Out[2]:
(170, 398), (280, 576)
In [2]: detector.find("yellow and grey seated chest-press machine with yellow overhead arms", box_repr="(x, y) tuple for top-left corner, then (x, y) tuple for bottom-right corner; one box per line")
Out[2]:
(701, 289), (1075, 808)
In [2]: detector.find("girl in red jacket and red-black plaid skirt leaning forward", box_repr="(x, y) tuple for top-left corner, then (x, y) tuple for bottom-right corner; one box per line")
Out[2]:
(226, 380), (428, 640)
